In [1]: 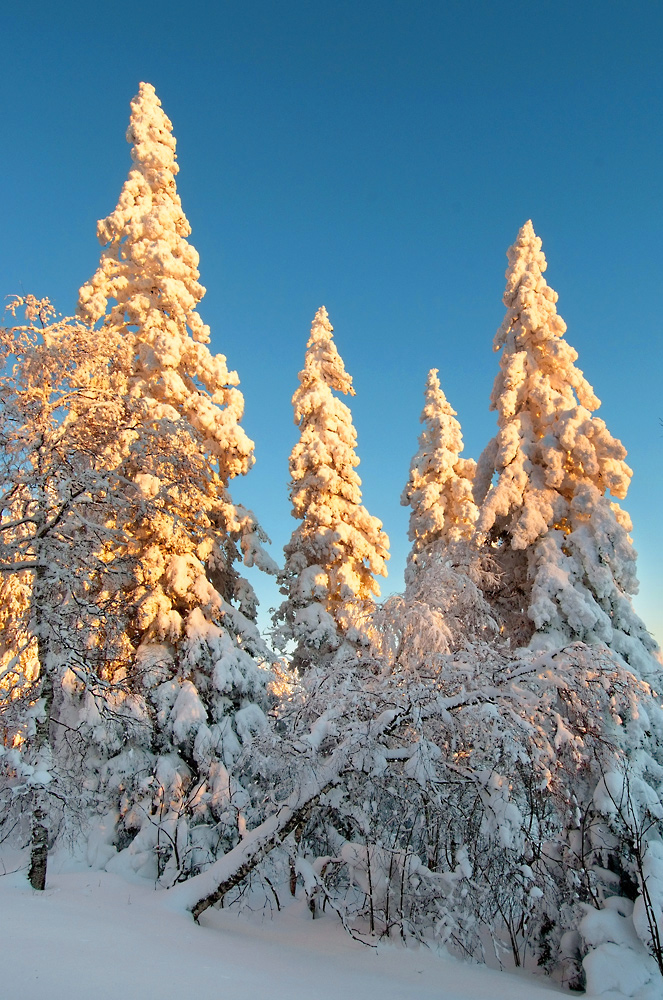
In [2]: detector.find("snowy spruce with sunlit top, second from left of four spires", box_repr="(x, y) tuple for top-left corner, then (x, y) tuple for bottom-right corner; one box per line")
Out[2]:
(277, 306), (389, 663)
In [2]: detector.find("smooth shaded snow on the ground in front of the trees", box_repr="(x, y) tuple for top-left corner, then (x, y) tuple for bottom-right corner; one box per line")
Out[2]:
(0, 863), (570, 1000)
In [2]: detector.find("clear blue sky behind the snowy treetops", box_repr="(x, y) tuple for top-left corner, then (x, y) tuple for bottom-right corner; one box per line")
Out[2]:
(0, 0), (663, 641)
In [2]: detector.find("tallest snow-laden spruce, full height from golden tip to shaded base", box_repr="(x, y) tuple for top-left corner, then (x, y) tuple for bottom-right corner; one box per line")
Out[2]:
(79, 83), (276, 880)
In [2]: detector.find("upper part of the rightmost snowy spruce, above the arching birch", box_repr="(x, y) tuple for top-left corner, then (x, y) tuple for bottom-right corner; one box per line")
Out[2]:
(475, 222), (658, 679)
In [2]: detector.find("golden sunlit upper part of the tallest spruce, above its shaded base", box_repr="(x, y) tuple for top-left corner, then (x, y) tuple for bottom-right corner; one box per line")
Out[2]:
(79, 83), (276, 640)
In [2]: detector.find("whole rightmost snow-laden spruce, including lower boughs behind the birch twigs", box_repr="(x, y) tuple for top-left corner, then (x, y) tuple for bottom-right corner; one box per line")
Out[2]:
(475, 222), (663, 984)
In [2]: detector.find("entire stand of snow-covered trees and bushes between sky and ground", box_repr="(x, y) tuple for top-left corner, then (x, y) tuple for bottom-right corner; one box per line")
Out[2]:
(0, 84), (663, 1000)
